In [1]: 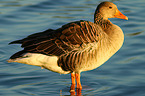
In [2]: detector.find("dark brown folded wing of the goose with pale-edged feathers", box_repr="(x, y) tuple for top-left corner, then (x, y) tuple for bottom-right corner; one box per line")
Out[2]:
(10, 20), (102, 58)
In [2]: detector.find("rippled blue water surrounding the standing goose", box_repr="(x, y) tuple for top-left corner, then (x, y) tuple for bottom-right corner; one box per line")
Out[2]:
(0, 0), (145, 96)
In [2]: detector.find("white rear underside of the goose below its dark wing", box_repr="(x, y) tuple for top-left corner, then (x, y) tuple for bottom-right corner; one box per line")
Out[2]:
(8, 53), (70, 74)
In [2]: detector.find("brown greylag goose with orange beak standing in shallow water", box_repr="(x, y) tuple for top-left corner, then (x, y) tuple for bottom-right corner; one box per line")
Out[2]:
(8, 2), (128, 89)
